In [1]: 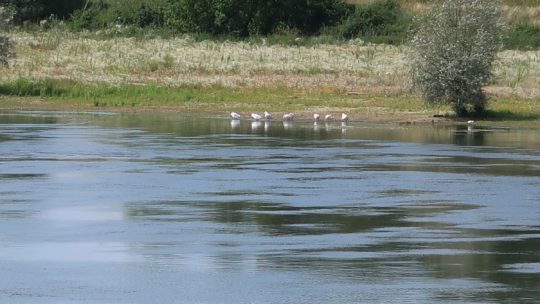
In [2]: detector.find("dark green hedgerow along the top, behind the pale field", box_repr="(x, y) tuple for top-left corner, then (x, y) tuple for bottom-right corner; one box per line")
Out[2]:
(0, 0), (540, 49)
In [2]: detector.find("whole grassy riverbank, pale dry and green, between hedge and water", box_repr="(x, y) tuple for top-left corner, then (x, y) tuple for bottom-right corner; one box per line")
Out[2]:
(0, 29), (540, 125)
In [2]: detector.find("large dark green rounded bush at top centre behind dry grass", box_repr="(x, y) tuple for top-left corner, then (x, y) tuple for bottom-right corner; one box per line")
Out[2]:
(165, 0), (350, 37)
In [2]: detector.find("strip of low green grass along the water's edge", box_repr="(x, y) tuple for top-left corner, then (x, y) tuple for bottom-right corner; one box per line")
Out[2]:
(0, 79), (540, 128)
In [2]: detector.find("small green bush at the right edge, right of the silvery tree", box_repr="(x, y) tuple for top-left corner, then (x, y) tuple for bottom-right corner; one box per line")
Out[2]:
(504, 20), (540, 50)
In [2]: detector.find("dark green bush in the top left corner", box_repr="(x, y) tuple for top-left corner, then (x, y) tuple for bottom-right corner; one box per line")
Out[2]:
(0, 0), (86, 24)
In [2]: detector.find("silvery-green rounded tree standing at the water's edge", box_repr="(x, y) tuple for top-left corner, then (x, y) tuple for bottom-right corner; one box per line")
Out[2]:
(410, 0), (504, 116)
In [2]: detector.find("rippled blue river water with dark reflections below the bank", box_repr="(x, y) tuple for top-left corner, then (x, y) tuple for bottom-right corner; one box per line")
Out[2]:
(0, 112), (540, 304)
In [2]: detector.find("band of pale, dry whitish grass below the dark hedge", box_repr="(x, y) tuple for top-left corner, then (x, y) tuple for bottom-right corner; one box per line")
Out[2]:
(0, 30), (540, 99)
